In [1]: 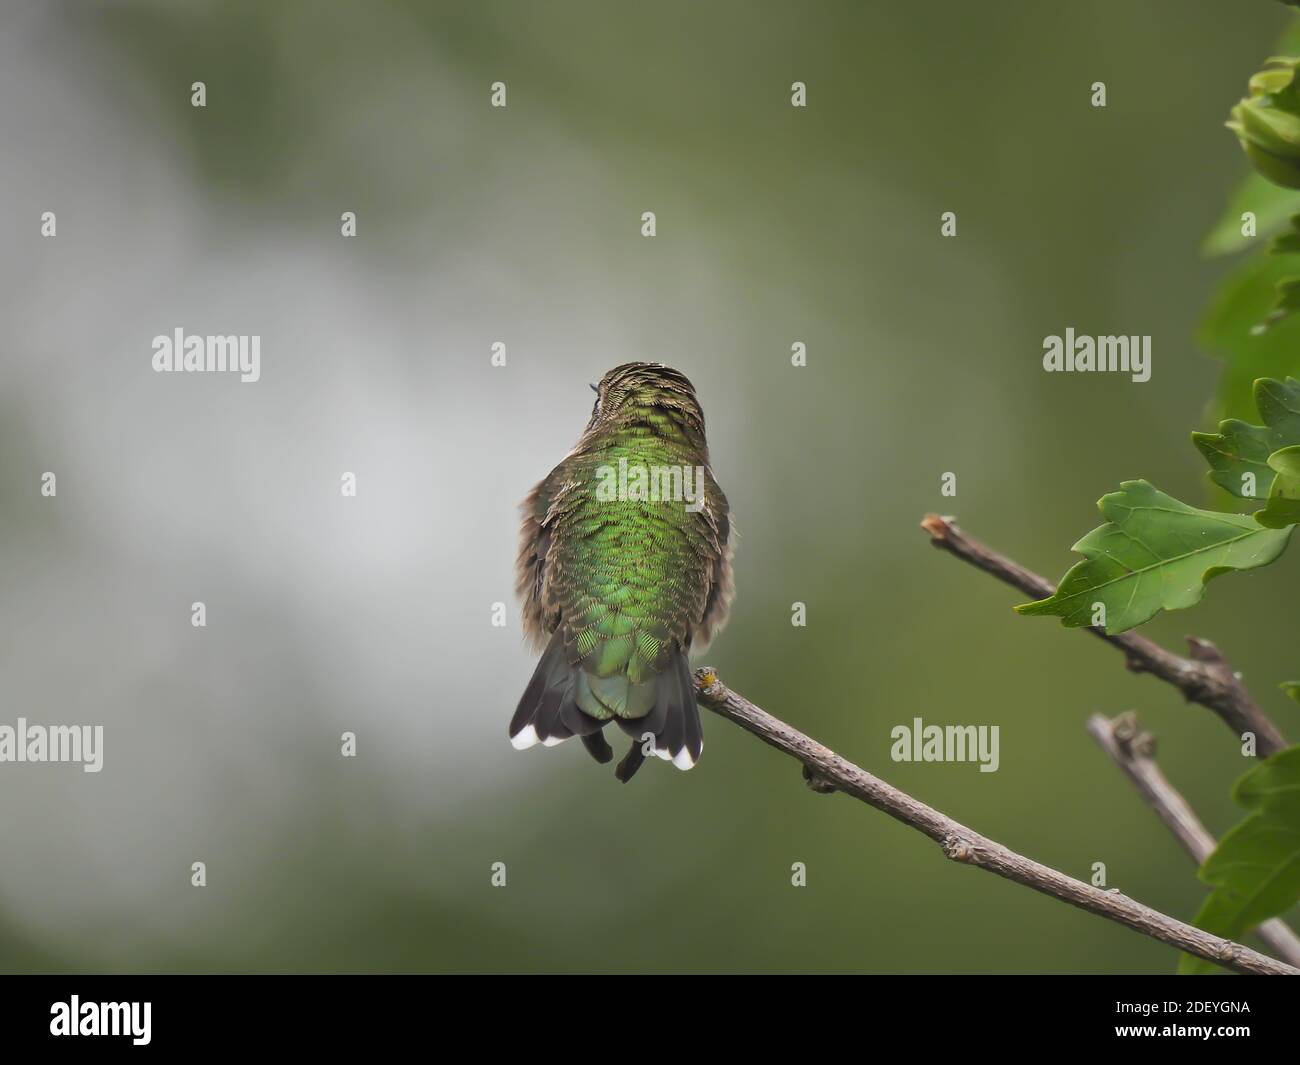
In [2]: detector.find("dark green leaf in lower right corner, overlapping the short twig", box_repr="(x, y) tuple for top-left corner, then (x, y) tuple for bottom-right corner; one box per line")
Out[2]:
(1178, 746), (1300, 974)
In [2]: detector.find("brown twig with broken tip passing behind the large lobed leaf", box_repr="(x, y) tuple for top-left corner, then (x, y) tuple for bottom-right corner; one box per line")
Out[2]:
(920, 514), (1287, 758)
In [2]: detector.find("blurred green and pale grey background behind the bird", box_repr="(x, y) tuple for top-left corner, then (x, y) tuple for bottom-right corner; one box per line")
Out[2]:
(0, 0), (1300, 973)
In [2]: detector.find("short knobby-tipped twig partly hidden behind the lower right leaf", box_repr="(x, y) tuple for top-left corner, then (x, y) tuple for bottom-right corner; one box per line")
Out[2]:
(1088, 711), (1300, 965)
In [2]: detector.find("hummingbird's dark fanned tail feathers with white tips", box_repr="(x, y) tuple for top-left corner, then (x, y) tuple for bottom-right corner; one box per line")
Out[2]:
(510, 631), (705, 782)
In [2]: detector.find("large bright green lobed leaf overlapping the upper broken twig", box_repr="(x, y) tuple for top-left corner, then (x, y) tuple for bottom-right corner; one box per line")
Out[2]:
(1015, 481), (1291, 633)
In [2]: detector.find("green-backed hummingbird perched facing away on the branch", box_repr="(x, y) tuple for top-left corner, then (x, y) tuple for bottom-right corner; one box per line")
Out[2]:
(510, 363), (732, 783)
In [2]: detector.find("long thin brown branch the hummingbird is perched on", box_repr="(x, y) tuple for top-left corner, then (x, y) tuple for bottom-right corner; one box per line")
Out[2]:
(696, 667), (1300, 975)
